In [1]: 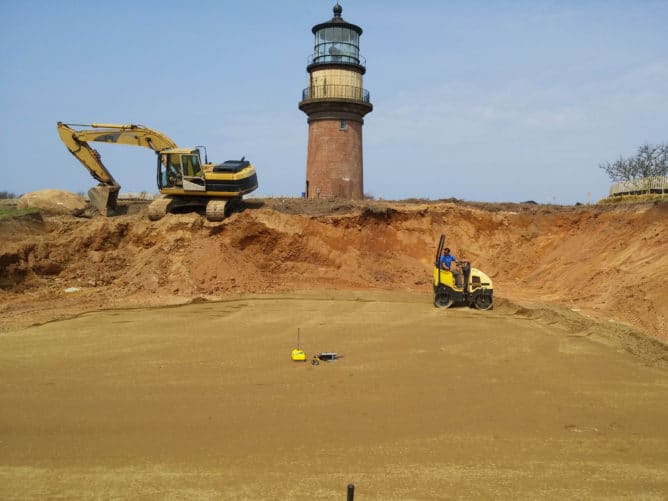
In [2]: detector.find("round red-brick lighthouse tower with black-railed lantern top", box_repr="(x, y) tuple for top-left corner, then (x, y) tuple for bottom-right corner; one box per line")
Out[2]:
(299, 2), (373, 200)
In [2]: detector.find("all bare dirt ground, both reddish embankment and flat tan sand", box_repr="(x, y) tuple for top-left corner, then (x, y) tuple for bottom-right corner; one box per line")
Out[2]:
(0, 199), (668, 499)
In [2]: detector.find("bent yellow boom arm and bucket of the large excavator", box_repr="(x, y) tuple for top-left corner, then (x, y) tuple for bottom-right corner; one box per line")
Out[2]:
(58, 122), (176, 215)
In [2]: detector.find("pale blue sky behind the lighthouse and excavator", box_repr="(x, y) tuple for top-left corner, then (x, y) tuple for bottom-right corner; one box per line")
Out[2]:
(0, 0), (668, 204)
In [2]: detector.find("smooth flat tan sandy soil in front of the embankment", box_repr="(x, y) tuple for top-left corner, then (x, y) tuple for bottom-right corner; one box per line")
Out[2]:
(0, 291), (668, 499)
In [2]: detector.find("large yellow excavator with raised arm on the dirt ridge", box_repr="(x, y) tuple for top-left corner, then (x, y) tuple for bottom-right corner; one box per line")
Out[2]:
(58, 122), (258, 221)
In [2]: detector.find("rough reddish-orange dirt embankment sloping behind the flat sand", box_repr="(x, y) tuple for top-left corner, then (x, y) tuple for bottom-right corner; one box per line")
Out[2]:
(0, 199), (668, 340)
